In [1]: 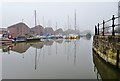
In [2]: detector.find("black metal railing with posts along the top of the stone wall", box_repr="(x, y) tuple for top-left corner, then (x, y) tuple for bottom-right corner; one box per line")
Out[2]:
(95, 15), (120, 36)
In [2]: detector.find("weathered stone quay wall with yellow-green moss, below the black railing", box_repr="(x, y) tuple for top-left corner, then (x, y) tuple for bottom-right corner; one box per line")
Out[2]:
(93, 35), (120, 69)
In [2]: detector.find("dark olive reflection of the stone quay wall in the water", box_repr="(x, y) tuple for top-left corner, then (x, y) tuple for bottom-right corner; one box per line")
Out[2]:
(93, 51), (120, 81)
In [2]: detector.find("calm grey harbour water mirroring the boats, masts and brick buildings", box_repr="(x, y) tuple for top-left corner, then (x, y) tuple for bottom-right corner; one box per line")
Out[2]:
(2, 38), (118, 79)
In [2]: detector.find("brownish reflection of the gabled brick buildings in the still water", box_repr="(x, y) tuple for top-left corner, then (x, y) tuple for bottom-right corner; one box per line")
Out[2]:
(1, 40), (54, 54)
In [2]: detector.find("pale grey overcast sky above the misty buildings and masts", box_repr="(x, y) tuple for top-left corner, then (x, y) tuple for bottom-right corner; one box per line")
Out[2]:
(2, 2), (118, 31)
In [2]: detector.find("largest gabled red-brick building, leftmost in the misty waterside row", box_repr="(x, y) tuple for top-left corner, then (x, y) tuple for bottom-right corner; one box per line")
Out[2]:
(8, 23), (30, 37)
